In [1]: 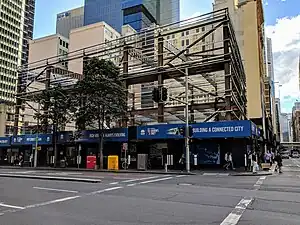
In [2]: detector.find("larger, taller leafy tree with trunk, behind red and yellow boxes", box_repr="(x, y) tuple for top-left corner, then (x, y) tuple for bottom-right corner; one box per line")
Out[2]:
(75, 57), (127, 169)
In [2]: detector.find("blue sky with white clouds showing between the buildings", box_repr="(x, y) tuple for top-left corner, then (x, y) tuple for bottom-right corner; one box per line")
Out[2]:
(34, 0), (300, 112)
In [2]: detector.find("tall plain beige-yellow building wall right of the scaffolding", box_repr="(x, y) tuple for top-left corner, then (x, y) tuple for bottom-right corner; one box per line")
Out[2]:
(214, 0), (265, 118)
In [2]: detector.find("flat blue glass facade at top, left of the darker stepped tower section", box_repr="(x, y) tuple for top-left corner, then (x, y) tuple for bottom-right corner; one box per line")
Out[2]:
(84, 0), (123, 32)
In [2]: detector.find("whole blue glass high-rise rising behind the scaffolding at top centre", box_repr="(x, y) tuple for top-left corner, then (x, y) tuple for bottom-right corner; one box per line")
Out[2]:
(84, 0), (180, 32)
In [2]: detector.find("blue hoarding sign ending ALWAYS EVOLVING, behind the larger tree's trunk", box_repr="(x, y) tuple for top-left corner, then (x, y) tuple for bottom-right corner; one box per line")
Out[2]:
(77, 128), (128, 143)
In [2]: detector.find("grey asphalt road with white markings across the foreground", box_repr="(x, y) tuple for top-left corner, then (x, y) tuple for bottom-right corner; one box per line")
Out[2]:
(0, 159), (300, 225)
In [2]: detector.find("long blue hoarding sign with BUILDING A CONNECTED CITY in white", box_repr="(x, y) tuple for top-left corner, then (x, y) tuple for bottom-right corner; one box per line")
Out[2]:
(137, 120), (251, 140)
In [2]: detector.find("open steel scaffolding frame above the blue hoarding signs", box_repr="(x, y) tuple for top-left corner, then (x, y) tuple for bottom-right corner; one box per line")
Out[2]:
(14, 9), (247, 132)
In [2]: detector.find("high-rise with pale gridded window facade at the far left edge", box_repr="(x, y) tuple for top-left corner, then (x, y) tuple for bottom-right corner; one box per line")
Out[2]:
(0, 0), (35, 136)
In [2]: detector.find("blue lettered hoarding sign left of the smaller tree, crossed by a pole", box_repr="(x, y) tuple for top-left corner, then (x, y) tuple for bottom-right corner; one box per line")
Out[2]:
(11, 134), (52, 145)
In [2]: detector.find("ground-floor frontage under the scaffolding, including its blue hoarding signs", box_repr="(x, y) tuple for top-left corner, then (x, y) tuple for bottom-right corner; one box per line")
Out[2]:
(0, 121), (259, 169)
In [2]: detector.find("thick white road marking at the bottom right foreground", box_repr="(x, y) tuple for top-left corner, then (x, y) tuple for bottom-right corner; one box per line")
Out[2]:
(220, 198), (253, 225)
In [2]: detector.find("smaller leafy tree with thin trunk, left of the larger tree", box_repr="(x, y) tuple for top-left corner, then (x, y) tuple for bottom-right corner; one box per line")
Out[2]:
(34, 85), (72, 166)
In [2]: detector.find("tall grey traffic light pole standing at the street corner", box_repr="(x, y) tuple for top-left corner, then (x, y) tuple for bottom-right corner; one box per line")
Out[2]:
(185, 68), (190, 172)
